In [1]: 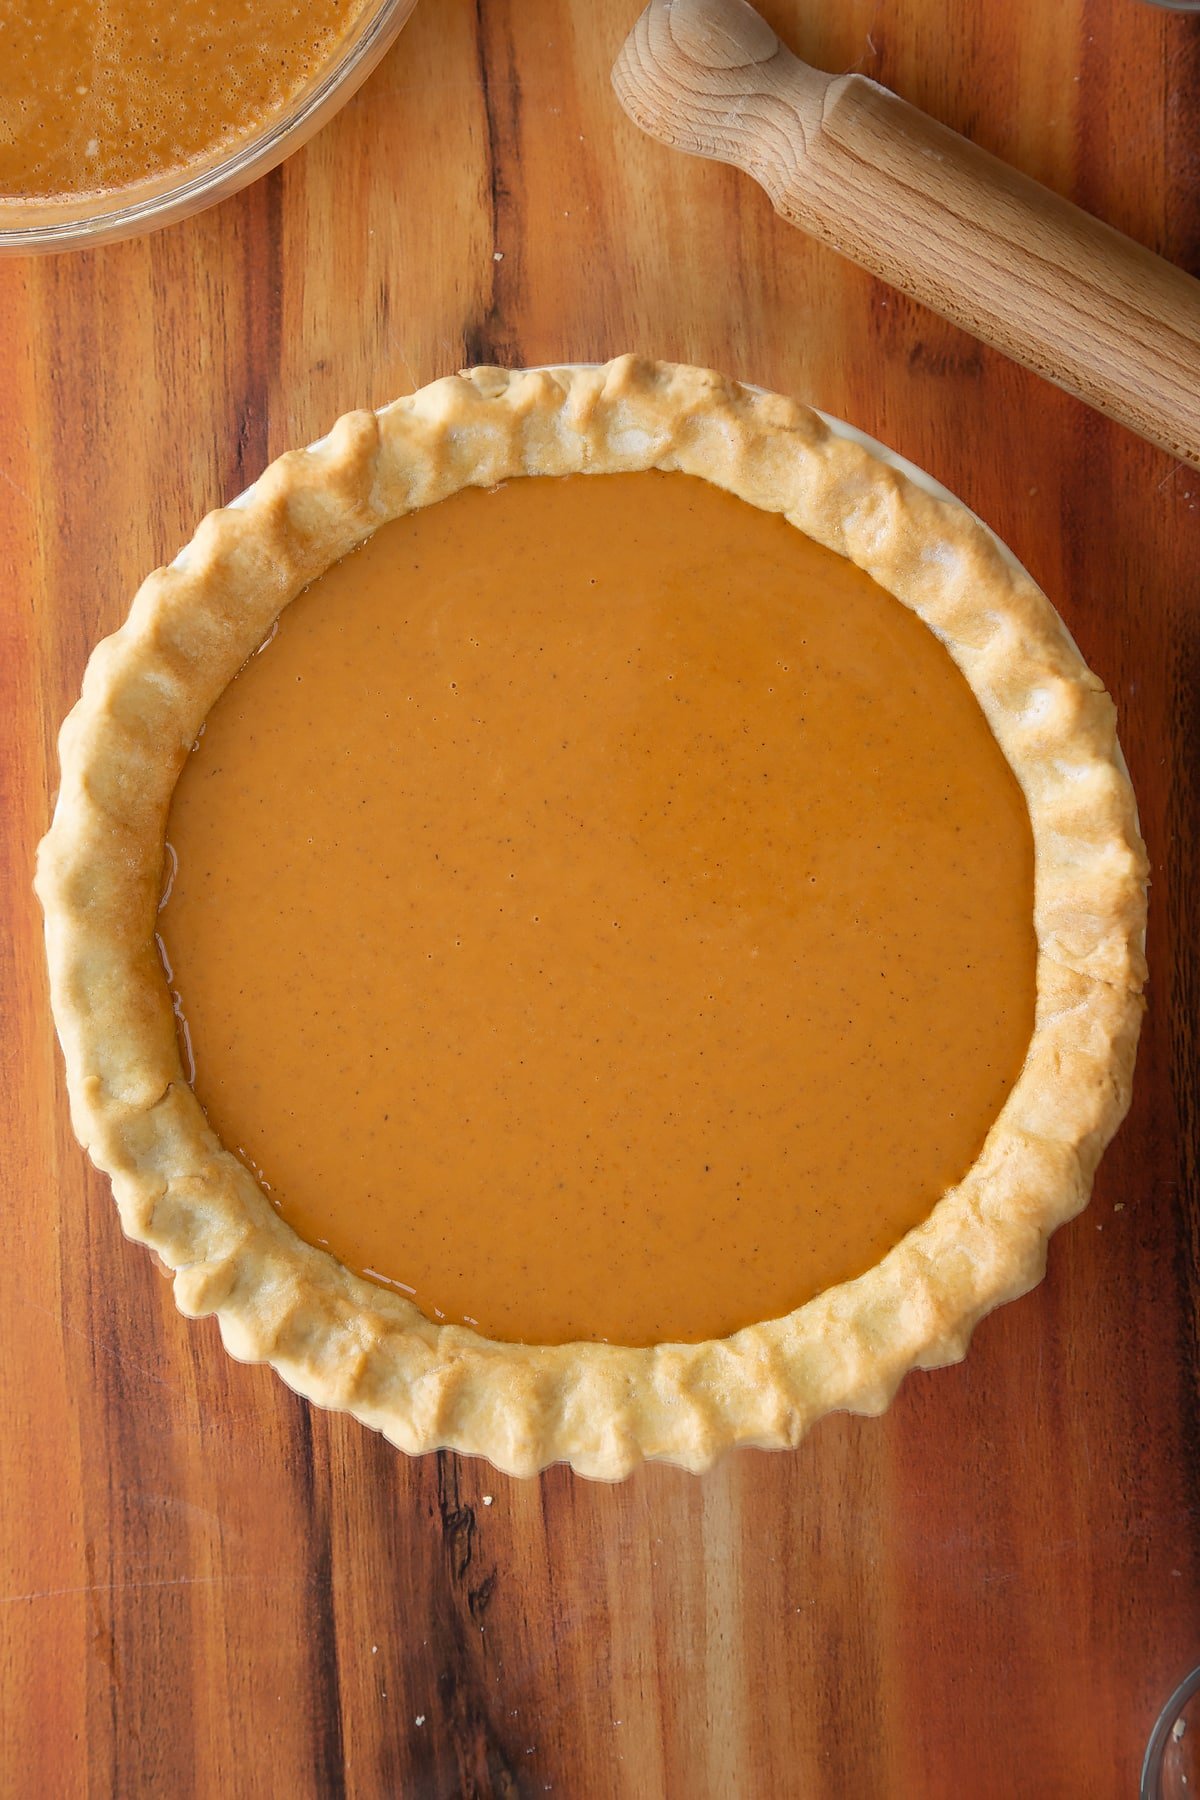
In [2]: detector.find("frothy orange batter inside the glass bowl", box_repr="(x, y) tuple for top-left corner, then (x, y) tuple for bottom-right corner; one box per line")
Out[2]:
(0, 0), (369, 200)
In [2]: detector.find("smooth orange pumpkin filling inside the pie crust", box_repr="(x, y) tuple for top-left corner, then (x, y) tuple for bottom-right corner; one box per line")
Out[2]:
(160, 475), (1034, 1345)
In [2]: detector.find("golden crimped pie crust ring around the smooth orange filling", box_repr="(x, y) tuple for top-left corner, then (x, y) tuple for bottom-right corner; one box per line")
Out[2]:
(36, 356), (1146, 1480)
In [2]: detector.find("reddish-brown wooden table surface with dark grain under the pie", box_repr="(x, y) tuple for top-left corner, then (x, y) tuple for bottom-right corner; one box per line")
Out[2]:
(0, 0), (1200, 1800)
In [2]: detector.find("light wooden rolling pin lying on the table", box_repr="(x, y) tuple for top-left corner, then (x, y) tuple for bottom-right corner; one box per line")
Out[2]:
(612, 0), (1200, 468)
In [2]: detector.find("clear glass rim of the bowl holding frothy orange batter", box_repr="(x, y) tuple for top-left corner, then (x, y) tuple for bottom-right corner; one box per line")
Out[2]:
(0, 0), (417, 256)
